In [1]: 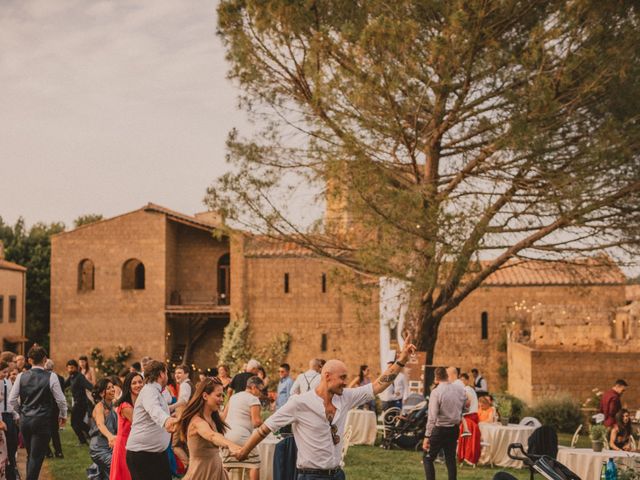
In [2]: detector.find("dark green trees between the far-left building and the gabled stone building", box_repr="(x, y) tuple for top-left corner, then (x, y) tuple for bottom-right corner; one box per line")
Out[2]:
(0, 217), (65, 349)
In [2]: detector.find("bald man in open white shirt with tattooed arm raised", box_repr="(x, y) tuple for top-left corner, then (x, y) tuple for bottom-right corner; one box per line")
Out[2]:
(238, 341), (415, 480)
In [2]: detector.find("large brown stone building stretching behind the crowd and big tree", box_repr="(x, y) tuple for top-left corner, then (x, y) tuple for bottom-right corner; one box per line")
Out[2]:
(51, 204), (640, 401)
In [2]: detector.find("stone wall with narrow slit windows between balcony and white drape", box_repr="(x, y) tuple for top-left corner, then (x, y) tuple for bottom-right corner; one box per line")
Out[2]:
(241, 254), (380, 376)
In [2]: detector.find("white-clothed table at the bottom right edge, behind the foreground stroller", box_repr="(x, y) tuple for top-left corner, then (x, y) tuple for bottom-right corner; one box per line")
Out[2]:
(558, 448), (640, 480)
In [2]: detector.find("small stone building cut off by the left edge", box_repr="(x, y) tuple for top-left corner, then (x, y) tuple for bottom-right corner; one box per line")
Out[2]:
(0, 241), (28, 353)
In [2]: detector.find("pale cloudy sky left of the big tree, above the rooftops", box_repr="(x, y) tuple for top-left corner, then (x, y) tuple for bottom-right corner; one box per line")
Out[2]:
(0, 0), (251, 227)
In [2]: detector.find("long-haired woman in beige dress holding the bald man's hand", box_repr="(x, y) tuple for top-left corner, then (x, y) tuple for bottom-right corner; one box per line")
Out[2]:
(179, 377), (240, 480)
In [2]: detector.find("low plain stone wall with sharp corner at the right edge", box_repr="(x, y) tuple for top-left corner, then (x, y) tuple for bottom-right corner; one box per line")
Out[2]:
(509, 343), (640, 409)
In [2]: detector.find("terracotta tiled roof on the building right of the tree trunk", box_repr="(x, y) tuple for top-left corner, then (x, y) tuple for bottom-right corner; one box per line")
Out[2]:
(482, 259), (626, 286)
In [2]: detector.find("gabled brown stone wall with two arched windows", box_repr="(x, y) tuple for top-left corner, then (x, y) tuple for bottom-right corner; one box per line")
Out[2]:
(51, 210), (167, 365)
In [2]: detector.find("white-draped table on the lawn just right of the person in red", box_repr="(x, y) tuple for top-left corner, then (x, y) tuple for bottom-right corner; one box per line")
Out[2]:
(478, 422), (535, 468)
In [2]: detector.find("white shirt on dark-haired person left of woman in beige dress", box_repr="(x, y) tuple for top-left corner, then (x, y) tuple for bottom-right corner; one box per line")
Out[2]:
(127, 382), (171, 452)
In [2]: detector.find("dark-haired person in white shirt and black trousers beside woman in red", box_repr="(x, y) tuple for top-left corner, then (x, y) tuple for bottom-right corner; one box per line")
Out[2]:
(127, 360), (178, 480)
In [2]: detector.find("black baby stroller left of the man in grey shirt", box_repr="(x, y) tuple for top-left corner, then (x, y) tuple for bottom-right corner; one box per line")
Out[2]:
(380, 400), (428, 450)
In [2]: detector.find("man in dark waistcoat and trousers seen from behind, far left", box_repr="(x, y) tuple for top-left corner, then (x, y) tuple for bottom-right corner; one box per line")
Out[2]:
(9, 345), (67, 480)
